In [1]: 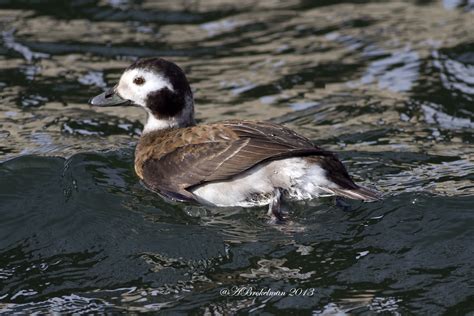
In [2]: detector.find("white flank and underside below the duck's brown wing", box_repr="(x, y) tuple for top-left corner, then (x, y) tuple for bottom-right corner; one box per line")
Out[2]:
(192, 157), (337, 207)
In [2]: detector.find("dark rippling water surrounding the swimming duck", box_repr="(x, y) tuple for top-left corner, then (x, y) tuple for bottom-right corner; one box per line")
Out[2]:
(0, 0), (474, 315)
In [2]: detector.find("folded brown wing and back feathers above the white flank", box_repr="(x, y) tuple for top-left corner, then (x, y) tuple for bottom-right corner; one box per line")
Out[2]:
(138, 121), (333, 199)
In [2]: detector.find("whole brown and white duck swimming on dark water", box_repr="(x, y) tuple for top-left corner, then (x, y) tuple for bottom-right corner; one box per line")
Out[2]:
(89, 57), (381, 221)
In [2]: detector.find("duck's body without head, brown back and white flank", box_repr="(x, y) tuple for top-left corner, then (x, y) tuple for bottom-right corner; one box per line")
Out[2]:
(135, 120), (378, 206)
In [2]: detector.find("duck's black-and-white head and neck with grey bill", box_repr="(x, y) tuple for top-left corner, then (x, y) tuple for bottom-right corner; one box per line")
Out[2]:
(89, 58), (195, 133)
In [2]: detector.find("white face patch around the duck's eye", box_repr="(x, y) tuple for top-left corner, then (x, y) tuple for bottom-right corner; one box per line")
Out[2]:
(117, 68), (174, 107)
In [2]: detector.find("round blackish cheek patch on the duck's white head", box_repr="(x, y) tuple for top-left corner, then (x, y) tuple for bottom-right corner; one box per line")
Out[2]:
(146, 87), (185, 118)
